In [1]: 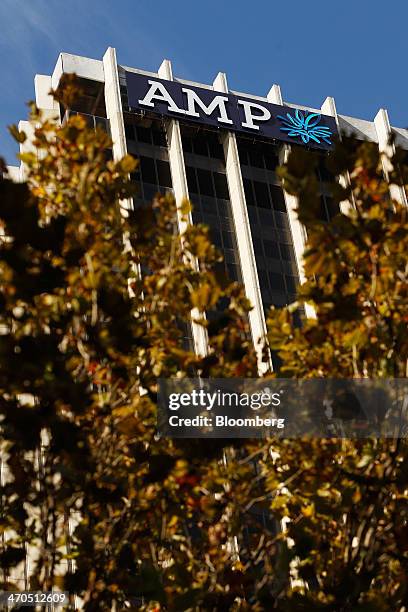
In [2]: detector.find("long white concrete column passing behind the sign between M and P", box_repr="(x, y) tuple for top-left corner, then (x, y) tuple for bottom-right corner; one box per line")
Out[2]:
(213, 72), (272, 373)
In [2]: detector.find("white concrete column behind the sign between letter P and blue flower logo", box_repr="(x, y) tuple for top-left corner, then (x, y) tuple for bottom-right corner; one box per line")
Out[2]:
(267, 84), (315, 317)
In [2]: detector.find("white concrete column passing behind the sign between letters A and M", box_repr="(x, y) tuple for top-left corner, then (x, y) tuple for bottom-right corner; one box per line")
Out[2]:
(158, 60), (208, 356)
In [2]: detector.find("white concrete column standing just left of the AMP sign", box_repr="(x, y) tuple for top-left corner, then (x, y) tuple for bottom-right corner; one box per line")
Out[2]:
(103, 47), (133, 210)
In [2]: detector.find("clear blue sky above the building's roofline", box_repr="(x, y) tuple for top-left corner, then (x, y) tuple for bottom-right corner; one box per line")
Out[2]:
(0, 0), (408, 163)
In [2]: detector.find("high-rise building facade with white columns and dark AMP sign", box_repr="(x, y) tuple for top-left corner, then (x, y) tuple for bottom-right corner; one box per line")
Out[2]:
(10, 48), (408, 368)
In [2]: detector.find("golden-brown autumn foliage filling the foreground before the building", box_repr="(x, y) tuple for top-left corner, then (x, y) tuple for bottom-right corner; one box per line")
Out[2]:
(0, 79), (408, 611)
